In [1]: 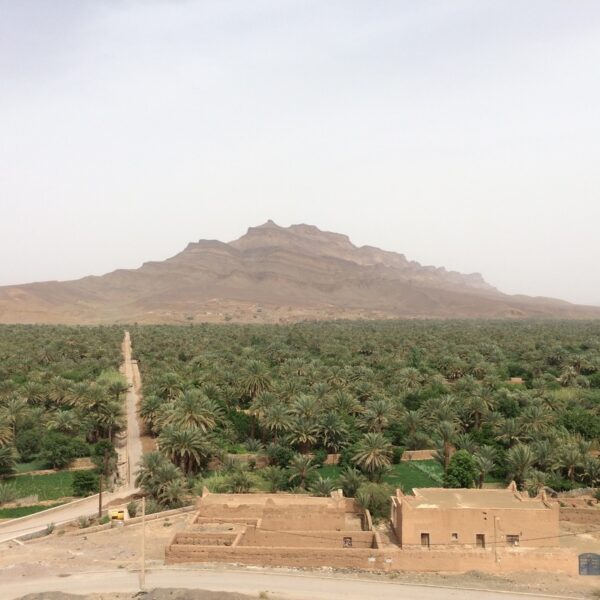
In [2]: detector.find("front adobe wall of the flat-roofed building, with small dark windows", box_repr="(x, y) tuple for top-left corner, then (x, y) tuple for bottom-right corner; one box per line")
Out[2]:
(395, 501), (559, 548)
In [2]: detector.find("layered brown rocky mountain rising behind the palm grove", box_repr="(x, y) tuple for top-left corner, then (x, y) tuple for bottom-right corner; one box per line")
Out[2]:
(0, 221), (600, 323)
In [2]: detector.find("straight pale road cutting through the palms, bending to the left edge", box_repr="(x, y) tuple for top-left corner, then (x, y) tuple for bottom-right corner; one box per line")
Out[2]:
(0, 331), (142, 543)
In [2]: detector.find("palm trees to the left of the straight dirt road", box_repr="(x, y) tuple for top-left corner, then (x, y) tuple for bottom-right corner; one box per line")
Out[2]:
(0, 326), (127, 475)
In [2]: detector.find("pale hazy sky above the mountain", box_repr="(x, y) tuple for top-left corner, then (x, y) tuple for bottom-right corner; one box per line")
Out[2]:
(0, 0), (600, 304)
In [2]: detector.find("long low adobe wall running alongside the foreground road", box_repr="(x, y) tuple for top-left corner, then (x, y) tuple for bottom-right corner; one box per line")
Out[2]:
(165, 544), (578, 575)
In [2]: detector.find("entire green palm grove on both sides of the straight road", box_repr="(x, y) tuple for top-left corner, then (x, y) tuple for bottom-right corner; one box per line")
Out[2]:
(0, 321), (600, 510)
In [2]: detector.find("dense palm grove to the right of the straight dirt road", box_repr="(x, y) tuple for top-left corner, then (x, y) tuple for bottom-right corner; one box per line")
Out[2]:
(131, 321), (600, 513)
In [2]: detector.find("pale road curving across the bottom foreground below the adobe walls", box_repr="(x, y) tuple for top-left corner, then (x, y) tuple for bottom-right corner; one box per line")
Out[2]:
(2, 568), (576, 600)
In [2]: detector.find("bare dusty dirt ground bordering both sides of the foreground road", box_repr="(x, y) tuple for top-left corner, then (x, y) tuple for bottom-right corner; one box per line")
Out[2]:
(0, 514), (600, 600)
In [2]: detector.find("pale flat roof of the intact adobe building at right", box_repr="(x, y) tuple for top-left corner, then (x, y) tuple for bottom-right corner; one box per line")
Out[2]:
(402, 488), (548, 510)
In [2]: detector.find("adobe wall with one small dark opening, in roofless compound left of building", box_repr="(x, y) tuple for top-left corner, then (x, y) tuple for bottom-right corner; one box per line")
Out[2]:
(238, 526), (375, 550)
